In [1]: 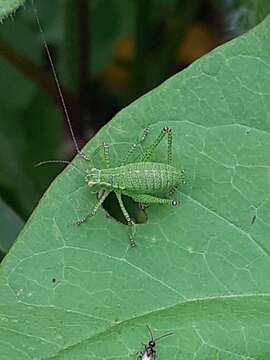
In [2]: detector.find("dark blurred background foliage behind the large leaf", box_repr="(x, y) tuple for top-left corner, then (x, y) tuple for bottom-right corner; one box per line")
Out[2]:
(0, 0), (270, 261)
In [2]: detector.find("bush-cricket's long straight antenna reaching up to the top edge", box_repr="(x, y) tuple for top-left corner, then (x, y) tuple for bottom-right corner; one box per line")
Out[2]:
(32, 0), (83, 158)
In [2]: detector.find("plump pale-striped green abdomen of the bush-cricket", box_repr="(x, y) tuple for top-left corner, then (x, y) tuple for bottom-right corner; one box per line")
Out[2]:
(100, 162), (183, 194)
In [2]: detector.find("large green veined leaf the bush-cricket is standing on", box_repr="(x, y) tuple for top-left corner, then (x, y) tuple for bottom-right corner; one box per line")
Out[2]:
(0, 17), (270, 360)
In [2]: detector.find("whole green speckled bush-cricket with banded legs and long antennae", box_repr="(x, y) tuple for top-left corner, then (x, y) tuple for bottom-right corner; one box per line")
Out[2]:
(32, 2), (184, 246)
